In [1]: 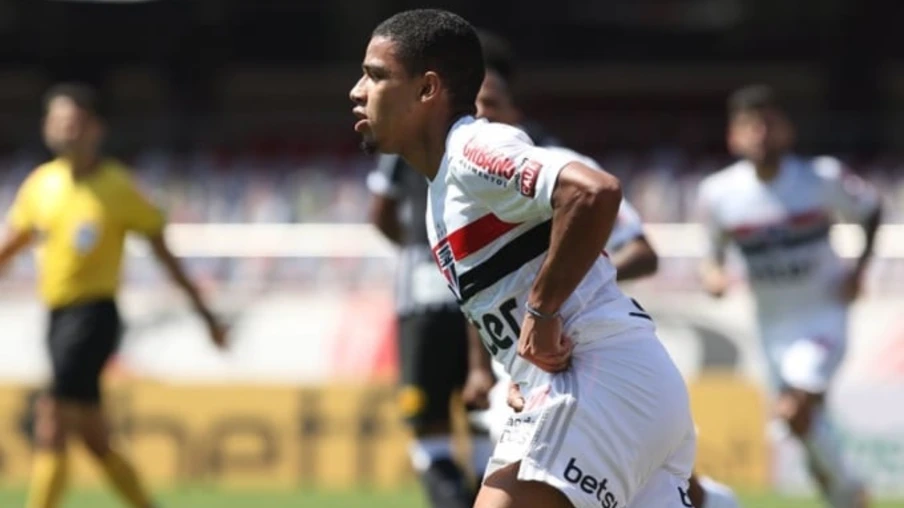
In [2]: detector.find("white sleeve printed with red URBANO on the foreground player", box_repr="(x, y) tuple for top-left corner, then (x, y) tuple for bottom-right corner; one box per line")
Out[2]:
(449, 129), (579, 223)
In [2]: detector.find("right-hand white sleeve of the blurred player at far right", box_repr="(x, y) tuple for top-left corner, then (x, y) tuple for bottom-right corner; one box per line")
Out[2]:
(813, 157), (879, 222)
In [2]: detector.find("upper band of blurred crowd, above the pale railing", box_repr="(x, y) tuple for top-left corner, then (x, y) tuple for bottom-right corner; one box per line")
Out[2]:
(0, 149), (904, 223)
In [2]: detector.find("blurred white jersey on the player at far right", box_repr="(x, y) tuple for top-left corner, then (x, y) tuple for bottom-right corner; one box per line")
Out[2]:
(699, 156), (879, 321)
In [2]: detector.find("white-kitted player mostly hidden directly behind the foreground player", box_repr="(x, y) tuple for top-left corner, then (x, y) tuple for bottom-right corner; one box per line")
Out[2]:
(464, 47), (738, 508)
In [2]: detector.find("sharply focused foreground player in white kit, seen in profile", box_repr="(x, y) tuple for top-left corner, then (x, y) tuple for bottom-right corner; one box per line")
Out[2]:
(350, 9), (696, 508)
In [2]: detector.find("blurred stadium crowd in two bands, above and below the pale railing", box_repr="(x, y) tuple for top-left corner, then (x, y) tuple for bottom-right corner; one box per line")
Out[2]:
(0, 149), (904, 291)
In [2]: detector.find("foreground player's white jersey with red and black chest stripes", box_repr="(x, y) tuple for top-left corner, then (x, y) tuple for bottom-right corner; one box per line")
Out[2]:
(427, 117), (652, 387)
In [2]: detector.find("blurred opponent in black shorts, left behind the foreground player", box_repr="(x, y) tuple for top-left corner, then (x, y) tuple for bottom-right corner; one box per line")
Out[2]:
(367, 32), (564, 507)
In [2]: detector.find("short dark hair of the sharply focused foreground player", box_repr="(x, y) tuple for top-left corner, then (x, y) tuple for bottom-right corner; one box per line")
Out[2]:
(373, 9), (485, 114)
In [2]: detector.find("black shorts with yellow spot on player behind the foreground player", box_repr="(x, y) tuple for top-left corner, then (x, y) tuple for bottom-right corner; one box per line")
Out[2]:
(398, 309), (468, 429)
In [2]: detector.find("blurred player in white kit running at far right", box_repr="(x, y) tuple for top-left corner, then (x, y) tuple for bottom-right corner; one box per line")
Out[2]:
(699, 85), (881, 508)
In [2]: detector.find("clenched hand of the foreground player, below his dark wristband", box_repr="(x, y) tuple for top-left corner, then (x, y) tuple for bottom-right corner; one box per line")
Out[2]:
(518, 314), (574, 373)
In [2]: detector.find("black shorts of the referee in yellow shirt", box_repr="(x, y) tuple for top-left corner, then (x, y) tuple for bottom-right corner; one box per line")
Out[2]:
(47, 298), (122, 404)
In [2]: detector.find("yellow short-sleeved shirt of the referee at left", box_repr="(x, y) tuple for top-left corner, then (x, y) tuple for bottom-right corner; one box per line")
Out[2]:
(9, 159), (164, 308)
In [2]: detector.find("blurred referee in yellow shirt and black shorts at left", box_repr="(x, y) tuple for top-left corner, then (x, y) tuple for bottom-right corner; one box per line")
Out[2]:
(0, 84), (225, 508)
